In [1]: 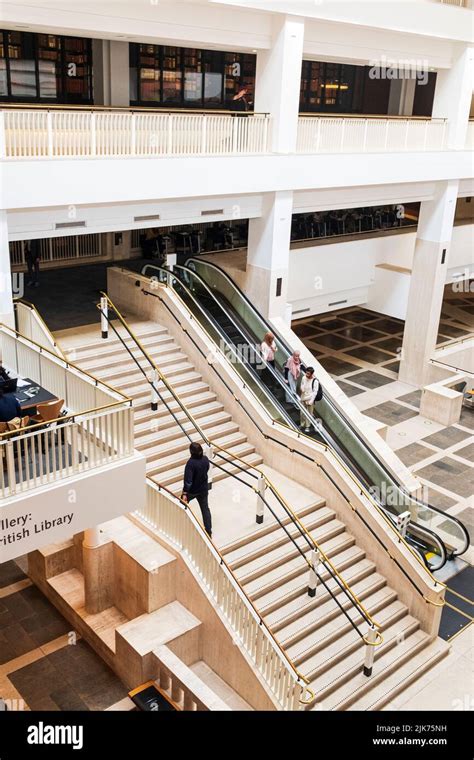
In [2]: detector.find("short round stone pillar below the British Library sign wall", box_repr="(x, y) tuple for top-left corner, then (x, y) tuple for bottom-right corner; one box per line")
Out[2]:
(82, 526), (113, 614)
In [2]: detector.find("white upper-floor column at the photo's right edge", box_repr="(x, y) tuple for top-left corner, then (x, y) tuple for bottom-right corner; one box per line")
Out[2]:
(433, 45), (473, 150)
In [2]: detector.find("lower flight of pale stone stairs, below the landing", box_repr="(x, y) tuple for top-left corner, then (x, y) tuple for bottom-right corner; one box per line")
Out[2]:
(221, 500), (449, 710)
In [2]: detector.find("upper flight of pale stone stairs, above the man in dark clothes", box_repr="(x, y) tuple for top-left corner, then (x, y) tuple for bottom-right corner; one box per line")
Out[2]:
(70, 320), (263, 494)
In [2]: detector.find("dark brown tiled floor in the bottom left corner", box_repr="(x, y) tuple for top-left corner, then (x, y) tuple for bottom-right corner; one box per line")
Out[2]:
(0, 561), (127, 710)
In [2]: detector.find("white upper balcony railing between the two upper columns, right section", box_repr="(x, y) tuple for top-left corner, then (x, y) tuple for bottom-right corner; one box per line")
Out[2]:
(296, 116), (447, 153)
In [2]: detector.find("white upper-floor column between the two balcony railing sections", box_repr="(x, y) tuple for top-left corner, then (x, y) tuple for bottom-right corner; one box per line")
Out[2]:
(254, 16), (304, 153)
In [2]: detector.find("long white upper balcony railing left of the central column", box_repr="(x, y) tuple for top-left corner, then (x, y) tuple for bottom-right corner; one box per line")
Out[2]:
(0, 109), (270, 158)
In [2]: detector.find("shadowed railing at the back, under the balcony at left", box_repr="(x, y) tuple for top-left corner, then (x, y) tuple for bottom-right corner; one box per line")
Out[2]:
(10, 233), (105, 266)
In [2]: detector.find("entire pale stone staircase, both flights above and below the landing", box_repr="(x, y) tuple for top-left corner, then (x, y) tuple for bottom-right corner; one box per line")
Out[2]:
(64, 321), (449, 710)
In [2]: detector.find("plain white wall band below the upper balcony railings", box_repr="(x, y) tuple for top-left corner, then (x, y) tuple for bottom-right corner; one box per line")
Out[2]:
(0, 151), (472, 209)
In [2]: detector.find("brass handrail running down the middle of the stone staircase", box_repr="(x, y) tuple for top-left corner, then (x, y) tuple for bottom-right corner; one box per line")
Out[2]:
(98, 291), (380, 628)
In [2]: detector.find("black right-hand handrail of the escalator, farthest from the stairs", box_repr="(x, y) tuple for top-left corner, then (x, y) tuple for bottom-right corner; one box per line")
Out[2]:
(186, 257), (470, 556)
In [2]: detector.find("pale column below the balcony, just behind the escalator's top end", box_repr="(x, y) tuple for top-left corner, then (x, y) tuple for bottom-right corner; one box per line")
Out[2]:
(246, 190), (293, 318)
